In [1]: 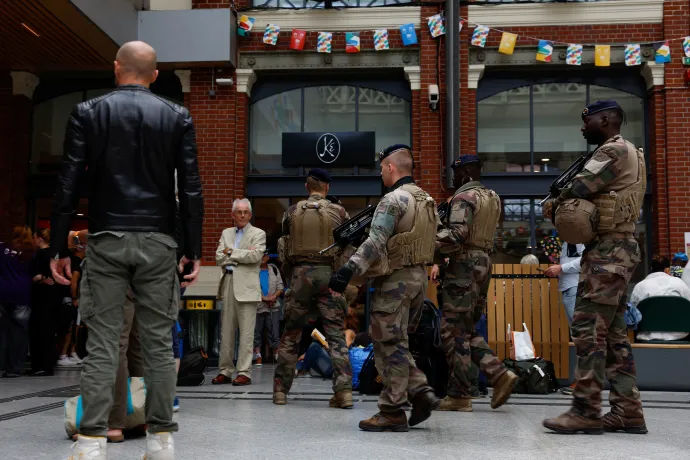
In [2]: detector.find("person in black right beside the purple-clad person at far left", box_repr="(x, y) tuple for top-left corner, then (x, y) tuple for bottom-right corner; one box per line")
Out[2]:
(29, 228), (61, 377)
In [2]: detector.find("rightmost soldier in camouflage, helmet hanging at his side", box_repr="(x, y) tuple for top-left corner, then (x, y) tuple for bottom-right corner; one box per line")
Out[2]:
(544, 101), (647, 434)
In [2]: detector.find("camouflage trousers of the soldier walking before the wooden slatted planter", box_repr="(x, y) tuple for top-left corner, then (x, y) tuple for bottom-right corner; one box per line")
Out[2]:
(441, 251), (506, 398)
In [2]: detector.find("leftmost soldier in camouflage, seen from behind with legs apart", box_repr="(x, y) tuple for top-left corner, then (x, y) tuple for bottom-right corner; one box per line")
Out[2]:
(273, 169), (353, 409)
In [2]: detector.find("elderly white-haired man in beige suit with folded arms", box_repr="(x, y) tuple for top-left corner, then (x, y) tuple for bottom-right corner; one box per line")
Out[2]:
(212, 198), (266, 386)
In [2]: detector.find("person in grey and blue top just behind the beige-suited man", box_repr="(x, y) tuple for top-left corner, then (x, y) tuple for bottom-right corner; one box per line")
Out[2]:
(254, 251), (285, 366)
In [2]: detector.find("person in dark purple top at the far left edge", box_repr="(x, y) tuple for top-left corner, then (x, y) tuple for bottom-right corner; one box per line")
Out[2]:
(0, 226), (34, 378)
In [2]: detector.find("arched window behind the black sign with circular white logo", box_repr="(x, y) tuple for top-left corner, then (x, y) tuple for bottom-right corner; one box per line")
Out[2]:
(249, 85), (411, 175)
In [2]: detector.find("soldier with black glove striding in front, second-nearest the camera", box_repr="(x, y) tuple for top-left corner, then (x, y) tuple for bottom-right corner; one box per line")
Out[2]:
(329, 145), (439, 431)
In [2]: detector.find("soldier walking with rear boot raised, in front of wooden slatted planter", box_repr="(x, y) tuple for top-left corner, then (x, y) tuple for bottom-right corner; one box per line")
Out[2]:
(431, 155), (517, 412)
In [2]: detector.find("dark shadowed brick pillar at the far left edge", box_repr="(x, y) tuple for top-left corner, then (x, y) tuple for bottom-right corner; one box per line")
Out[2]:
(0, 72), (33, 241)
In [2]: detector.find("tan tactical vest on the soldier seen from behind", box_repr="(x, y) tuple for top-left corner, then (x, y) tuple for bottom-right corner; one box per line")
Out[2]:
(286, 199), (333, 261)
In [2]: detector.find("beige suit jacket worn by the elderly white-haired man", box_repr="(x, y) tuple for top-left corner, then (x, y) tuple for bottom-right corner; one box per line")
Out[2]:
(216, 224), (266, 302)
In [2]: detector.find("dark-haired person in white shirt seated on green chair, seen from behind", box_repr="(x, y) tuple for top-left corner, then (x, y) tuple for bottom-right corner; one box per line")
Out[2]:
(630, 256), (690, 340)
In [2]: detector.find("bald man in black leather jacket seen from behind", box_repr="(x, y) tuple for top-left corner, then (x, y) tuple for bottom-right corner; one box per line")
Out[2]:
(49, 42), (203, 460)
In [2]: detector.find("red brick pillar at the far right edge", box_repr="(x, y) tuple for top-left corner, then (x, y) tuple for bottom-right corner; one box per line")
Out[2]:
(655, 0), (690, 254)
